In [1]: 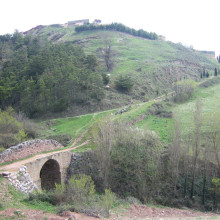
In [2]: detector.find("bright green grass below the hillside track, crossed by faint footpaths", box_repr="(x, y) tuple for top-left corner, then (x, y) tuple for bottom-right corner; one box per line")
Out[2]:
(38, 101), (173, 150)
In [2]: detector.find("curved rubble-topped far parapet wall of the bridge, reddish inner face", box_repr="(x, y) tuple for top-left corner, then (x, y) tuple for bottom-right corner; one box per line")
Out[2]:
(0, 139), (63, 163)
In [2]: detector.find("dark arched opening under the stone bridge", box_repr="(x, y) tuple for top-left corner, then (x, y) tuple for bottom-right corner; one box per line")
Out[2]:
(40, 159), (61, 190)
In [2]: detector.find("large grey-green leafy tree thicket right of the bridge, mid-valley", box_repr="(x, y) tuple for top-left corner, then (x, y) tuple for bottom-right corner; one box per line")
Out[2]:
(94, 120), (160, 201)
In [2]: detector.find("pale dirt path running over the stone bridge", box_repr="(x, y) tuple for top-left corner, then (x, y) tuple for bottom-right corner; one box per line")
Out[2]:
(0, 139), (89, 172)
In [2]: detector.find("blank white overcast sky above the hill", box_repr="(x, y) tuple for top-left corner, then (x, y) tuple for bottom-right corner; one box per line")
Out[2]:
(0, 0), (220, 55)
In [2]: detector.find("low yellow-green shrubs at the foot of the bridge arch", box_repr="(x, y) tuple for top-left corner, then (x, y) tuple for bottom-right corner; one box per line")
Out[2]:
(27, 174), (116, 217)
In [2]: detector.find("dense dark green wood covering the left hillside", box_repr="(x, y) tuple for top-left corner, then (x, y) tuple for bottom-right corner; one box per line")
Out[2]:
(0, 32), (104, 117)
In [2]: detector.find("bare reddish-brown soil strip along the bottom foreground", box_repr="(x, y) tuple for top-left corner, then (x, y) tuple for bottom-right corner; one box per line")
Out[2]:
(0, 205), (220, 220)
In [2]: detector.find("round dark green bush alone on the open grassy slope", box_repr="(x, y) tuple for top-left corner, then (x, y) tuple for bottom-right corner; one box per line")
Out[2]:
(115, 75), (134, 92)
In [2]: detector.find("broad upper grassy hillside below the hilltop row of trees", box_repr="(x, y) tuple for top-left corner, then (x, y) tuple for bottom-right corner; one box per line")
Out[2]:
(26, 26), (219, 110)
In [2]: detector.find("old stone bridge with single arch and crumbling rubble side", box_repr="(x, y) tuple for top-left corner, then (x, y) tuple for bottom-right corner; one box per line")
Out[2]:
(0, 140), (77, 193)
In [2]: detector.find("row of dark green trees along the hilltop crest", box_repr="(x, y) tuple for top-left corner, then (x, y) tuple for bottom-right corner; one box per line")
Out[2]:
(75, 23), (158, 40)
